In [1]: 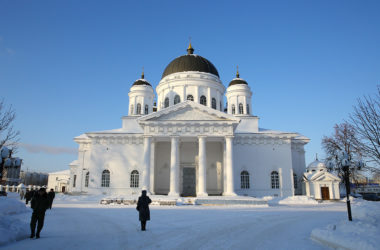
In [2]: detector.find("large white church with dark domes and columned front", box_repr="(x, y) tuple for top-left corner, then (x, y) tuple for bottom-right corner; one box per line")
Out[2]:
(70, 44), (309, 197)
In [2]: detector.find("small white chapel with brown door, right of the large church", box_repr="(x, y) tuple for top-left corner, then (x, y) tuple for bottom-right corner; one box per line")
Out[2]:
(303, 158), (341, 200)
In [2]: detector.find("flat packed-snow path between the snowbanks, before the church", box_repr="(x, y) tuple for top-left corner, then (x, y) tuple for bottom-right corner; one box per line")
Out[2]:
(3, 203), (346, 250)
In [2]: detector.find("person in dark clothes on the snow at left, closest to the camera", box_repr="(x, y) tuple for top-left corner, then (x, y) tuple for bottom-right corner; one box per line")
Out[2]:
(30, 188), (49, 239)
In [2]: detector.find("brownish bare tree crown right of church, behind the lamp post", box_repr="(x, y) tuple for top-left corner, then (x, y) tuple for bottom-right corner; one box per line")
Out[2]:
(322, 122), (362, 182)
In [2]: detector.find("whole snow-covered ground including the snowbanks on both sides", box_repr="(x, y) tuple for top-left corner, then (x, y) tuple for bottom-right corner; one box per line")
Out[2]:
(0, 194), (380, 250)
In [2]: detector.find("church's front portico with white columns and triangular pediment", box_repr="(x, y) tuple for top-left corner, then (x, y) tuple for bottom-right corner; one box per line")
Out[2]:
(138, 101), (239, 197)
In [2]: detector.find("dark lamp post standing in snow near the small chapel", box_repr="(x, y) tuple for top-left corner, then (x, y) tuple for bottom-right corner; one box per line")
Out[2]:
(327, 151), (364, 221)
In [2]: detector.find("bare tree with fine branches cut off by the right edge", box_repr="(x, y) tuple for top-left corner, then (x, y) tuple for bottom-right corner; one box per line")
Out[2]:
(350, 86), (380, 172)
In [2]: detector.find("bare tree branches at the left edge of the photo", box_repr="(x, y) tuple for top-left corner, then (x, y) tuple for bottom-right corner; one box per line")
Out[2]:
(0, 100), (20, 150)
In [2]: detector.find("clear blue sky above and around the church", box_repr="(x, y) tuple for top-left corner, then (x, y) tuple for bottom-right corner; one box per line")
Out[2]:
(0, 0), (380, 172)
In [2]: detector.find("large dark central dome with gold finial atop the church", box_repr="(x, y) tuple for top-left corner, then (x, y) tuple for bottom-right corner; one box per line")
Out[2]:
(162, 43), (219, 78)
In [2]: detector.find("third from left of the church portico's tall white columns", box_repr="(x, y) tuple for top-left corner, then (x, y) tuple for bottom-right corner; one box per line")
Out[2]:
(197, 136), (207, 197)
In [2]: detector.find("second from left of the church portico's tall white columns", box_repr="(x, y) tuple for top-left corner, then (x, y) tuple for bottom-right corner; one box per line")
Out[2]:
(168, 136), (179, 196)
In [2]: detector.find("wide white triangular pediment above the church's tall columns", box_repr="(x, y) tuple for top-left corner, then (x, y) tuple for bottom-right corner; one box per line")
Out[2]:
(138, 101), (240, 124)
